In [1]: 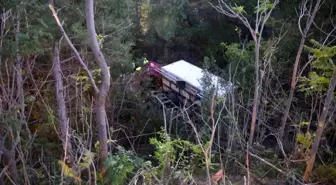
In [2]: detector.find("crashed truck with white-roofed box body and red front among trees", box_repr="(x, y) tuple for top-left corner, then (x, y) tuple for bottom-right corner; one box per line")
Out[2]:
(139, 60), (232, 105)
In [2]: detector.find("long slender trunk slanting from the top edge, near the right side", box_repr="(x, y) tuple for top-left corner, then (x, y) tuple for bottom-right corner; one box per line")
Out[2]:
(279, 0), (321, 142)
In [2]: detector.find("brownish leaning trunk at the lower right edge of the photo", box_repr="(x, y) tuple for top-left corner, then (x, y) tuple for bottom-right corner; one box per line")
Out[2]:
(303, 71), (336, 182)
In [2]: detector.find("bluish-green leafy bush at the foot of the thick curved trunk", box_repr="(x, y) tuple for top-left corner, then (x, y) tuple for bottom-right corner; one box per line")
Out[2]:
(104, 147), (143, 185)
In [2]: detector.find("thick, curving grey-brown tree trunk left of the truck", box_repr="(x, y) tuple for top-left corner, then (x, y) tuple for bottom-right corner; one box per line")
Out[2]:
(85, 0), (110, 162)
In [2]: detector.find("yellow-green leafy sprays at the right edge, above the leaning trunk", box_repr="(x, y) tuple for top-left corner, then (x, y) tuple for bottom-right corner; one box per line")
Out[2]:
(299, 40), (336, 95)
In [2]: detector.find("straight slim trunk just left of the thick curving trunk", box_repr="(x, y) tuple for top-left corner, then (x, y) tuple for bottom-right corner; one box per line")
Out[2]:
(53, 41), (74, 167)
